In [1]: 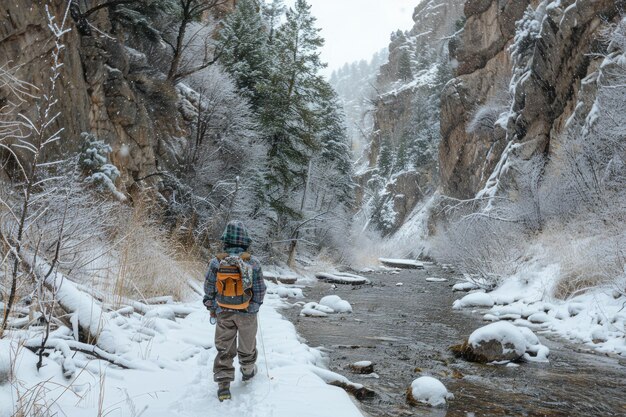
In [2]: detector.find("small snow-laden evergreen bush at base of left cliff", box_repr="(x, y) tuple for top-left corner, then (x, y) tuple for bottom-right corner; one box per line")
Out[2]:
(79, 132), (126, 201)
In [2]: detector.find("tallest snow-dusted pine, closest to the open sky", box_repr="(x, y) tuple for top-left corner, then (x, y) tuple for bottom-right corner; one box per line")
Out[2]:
(261, 0), (327, 216)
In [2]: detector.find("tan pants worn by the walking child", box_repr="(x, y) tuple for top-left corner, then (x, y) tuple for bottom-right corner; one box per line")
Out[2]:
(213, 311), (257, 382)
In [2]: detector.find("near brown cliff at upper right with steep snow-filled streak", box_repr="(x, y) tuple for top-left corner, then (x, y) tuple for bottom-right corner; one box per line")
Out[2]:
(439, 0), (625, 198)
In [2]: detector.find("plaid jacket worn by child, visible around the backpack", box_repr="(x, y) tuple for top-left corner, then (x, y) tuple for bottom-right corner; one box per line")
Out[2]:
(203, 247), (266, 314)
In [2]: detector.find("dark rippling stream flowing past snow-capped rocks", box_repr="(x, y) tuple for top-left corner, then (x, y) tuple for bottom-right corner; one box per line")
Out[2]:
(283, 266), (626, 417)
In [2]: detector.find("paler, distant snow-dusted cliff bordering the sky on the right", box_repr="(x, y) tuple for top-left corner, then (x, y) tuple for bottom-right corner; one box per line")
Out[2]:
(357, 0), (463, 233)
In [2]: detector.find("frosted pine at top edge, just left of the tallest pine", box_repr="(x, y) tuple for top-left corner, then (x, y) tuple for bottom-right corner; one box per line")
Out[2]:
(219, 0), (269, 109)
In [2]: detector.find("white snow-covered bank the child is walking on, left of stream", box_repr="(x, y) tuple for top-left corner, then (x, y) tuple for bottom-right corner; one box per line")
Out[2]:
(0, 284), (361, 417)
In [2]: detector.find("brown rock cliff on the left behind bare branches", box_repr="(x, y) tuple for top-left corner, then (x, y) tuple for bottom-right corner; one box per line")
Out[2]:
(0, 0), (234, 189)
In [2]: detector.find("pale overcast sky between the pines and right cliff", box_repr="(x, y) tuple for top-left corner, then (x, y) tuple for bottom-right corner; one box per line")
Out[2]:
(285, 0), (420, 75)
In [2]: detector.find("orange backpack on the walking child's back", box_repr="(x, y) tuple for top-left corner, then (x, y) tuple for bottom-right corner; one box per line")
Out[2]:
(215, 252), (252, 310)
